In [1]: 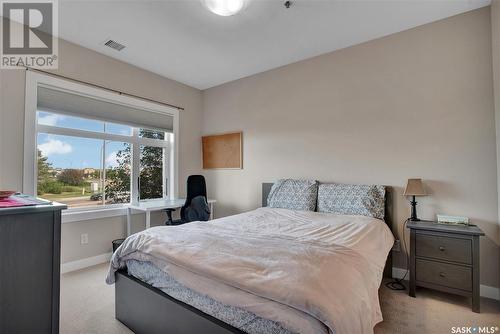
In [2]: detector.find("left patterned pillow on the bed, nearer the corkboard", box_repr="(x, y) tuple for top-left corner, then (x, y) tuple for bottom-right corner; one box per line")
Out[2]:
(267, 179), (318, 211)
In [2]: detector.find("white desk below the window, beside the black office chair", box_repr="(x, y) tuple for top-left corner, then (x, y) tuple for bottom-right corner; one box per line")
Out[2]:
(127, 198), (216, 236)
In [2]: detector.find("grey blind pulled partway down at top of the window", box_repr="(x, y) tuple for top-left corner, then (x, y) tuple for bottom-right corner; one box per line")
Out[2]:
(37, 86), (174, 132)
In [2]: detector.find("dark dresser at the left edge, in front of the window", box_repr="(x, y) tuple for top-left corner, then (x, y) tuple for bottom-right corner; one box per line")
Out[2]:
(0, 203), (66, 334)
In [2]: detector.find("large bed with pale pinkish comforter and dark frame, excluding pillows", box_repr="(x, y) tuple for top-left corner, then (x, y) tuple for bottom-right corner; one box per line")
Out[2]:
(107, 184), (393, 334)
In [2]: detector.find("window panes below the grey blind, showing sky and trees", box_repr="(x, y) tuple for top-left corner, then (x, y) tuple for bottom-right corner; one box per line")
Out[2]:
(37, 110), (170, 208)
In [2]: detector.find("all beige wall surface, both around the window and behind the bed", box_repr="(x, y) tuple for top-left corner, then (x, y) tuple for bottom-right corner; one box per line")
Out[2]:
(0, 7), (500, 286)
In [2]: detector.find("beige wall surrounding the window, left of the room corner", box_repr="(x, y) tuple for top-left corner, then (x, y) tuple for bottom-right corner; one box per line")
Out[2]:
(0, 28), (202, 263)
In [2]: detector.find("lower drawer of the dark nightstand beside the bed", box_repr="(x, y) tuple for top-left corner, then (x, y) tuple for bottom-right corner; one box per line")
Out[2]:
(416, 259), (472, 291)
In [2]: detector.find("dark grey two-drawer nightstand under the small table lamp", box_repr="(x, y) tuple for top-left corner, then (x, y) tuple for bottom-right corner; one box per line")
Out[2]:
(407, 221), (484, 313)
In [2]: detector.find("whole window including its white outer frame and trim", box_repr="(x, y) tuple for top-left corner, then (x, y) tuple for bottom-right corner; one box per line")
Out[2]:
(23, 72), (178, 215)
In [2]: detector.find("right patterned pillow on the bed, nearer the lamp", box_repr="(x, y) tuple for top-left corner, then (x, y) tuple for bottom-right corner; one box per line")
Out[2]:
(318, 183), (385, 219)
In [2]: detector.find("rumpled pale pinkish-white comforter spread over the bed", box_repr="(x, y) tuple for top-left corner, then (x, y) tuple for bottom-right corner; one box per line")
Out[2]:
(106, 208), (394, 334)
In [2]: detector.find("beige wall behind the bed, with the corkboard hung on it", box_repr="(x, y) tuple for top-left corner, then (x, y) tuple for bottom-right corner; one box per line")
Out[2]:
(203, 7), (499, 286)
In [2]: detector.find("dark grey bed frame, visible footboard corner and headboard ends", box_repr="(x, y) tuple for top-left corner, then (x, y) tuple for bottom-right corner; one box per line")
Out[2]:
(115, 183), (392, 334)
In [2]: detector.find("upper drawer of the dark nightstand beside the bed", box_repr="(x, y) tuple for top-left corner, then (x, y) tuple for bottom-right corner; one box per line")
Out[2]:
(415, 233), (472, 264)
